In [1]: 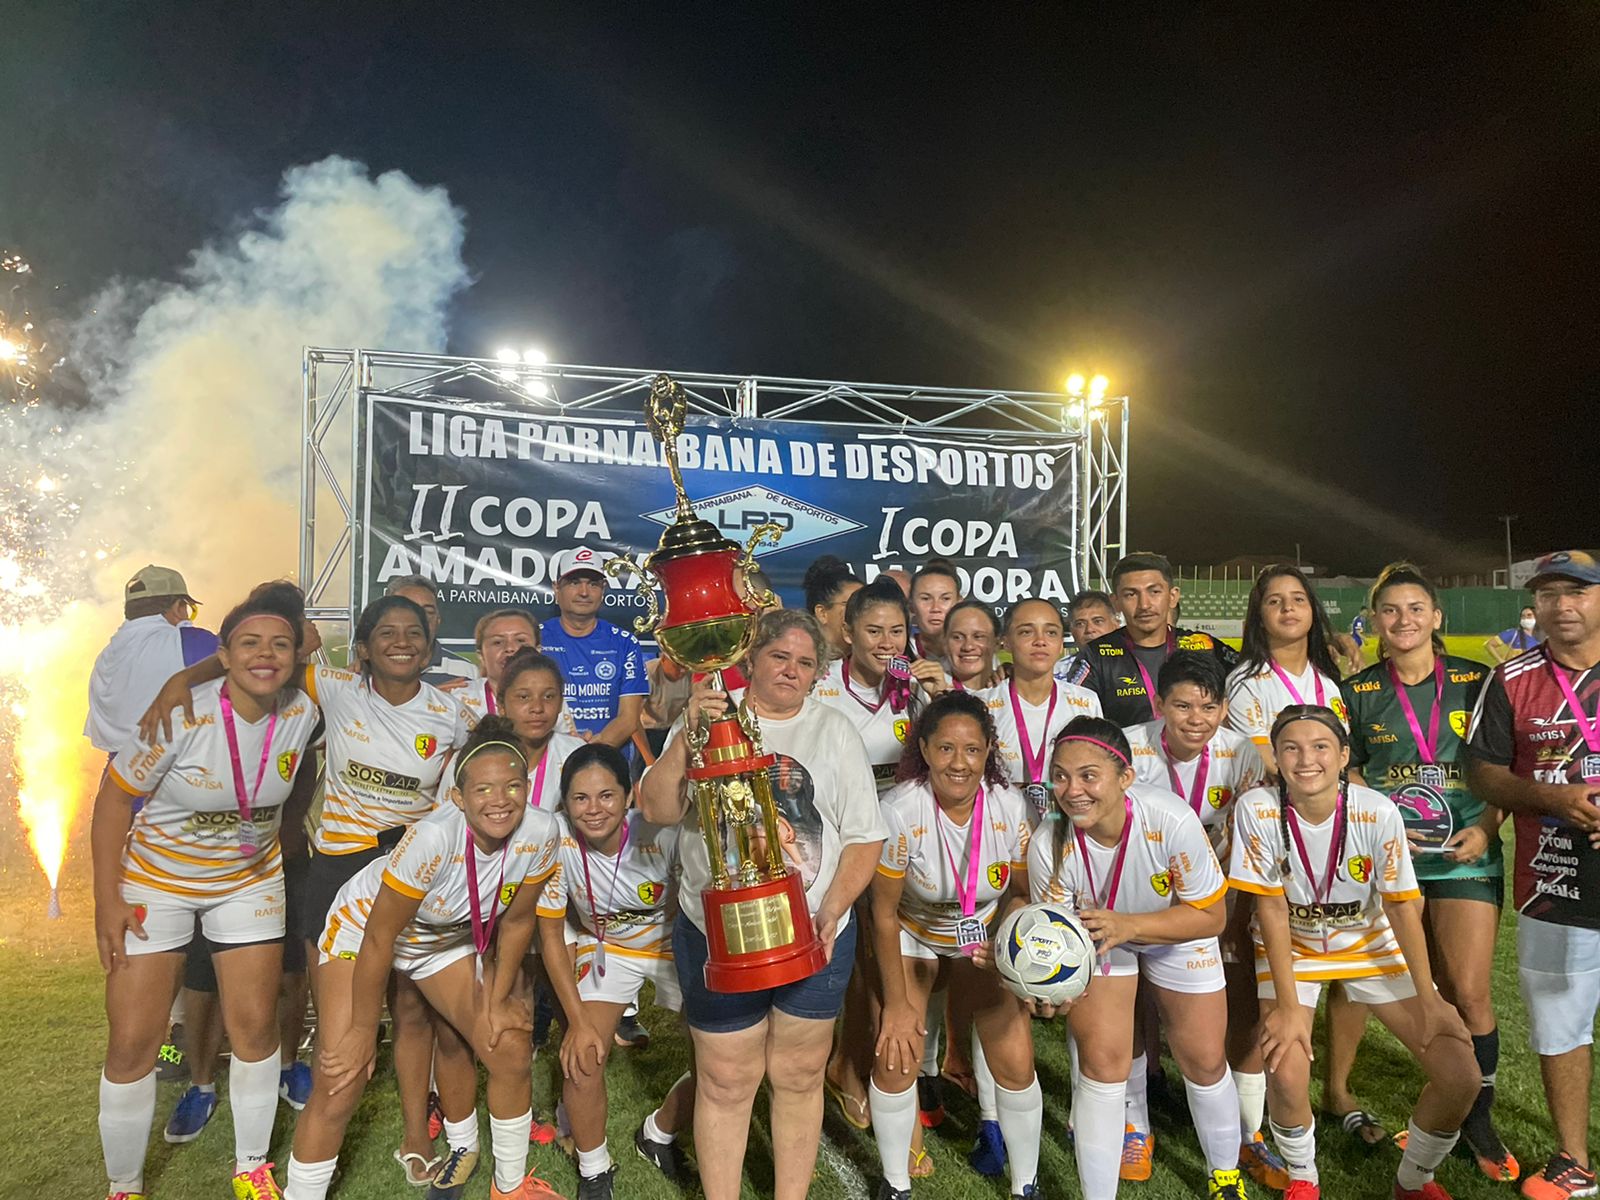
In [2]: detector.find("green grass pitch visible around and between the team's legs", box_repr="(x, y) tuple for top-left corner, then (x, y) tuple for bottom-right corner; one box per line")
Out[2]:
(0, 832), (1593, 1200)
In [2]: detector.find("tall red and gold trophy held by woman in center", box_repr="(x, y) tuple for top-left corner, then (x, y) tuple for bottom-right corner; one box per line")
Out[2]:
(606, 374), (827, 992)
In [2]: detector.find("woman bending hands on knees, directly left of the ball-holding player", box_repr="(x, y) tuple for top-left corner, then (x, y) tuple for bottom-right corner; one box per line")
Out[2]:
(872, 691), (1043, 1200)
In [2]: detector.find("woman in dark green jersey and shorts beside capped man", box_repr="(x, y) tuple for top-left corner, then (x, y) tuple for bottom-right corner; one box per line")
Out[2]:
(1330, 563), (1518, 1182)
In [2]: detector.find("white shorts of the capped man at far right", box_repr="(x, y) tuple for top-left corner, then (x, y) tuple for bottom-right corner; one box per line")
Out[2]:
(1517, 917), (1600, 1056)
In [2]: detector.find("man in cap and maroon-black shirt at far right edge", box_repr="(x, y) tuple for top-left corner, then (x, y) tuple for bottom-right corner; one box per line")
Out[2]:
(1467, 550), (1600, 1200)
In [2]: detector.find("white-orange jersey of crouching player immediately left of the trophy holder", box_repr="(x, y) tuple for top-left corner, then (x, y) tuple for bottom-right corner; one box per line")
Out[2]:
(539, 811), (678, 958)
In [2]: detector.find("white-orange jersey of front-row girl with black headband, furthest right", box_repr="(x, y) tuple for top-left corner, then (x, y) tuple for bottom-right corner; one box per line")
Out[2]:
(1229, 784), (1422, 981)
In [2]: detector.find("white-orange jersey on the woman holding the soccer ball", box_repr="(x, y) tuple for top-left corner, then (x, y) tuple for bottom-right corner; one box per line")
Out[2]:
(1027, 782), (1227, 914)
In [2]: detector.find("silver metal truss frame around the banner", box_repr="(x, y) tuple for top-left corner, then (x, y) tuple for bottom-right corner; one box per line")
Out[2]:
(299, 347), (1128, 640)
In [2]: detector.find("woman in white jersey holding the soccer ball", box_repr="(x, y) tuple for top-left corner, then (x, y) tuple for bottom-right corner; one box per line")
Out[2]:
(1027, 717), (1245, 1200)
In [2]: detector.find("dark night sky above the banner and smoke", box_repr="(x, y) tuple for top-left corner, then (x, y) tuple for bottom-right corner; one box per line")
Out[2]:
(0, 3), (1600, 571)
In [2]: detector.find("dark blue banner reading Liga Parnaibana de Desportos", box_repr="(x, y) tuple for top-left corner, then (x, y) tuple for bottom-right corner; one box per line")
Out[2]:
(360, 395), (1078, 645)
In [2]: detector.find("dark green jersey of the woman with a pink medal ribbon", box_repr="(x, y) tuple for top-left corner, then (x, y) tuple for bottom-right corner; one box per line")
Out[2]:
(1339, 654), (1502, 880)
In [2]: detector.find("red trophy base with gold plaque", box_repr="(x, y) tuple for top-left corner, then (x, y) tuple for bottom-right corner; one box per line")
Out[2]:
(701, 874), (827, 992)
